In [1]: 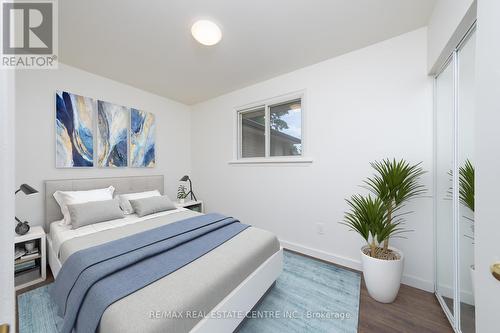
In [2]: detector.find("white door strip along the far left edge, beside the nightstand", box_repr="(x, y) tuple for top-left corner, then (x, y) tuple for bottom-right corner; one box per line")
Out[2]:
(0, 69), (15, 326)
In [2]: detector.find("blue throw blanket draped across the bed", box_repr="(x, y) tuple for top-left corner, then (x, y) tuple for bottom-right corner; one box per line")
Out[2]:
(52, 214), (248, 333)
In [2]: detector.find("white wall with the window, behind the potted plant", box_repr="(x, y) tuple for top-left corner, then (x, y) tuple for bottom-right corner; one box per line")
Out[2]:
(191, 28), (433, 290)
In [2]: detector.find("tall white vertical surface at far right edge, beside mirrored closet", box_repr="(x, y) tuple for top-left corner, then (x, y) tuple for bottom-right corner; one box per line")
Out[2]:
(474, 0), (500, 333)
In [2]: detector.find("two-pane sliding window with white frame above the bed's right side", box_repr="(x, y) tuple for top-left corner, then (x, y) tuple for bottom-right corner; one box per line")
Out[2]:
(238, 97), (303, 160)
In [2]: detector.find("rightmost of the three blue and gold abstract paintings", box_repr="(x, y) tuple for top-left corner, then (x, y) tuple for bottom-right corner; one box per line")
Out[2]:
(130, 109), (156, 168)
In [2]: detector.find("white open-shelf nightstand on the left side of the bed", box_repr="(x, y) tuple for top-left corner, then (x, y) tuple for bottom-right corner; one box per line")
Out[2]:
(14, 226), (47, 290)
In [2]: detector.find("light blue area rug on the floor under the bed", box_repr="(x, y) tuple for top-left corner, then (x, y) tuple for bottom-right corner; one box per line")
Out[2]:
(18, 251), (360, 333)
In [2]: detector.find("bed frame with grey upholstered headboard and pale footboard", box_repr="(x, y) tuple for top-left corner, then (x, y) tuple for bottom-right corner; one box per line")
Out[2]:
(44, 175), (283, 333)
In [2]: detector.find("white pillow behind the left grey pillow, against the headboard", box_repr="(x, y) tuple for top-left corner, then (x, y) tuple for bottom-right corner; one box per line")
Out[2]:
(53, 186), (115, 225)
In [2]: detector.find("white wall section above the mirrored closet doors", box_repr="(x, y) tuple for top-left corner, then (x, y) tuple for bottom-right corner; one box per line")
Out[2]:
(427, 0), (476, 73)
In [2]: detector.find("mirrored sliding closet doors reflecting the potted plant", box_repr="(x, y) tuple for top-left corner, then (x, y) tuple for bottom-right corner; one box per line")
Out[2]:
(434, 27), (475, 333)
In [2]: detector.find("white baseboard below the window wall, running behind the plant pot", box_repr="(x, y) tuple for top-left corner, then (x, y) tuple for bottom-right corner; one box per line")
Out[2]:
(280, 239), (434, 293)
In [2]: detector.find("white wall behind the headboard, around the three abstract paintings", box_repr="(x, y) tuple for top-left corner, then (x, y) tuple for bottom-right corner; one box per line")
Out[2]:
(15, 64), (190, 225)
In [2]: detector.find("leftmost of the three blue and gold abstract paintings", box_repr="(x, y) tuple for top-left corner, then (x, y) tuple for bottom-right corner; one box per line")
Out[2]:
(56, 91), (96, 168)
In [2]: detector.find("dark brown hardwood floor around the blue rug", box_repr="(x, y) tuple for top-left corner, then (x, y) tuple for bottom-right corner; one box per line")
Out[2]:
(16, 253), (453, 333)
